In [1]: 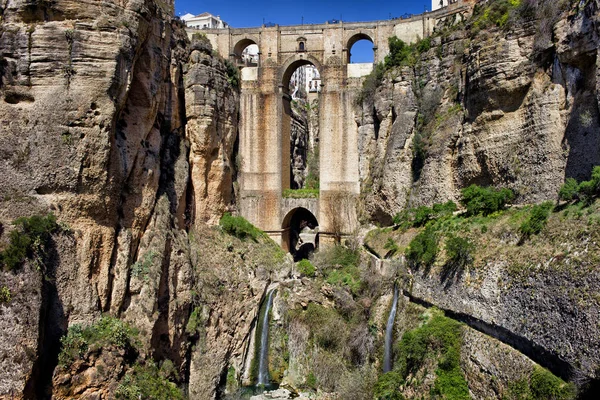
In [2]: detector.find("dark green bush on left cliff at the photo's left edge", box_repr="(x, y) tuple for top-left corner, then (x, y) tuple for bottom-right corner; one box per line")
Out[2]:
(0, 214), (60, 270)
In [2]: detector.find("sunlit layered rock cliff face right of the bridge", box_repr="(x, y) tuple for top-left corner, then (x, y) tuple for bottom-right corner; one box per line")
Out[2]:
(357, 1), (600, 221)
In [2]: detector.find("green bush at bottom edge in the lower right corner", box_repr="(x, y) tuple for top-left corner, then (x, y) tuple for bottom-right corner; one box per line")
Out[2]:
(502, 366), (577, 400)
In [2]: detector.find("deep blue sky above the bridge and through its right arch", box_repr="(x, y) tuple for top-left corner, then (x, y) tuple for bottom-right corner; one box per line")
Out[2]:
(175, 0), (431, 62)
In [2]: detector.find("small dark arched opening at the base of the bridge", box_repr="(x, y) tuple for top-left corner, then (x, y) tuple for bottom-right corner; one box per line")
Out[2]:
(281, 207), (319, 261)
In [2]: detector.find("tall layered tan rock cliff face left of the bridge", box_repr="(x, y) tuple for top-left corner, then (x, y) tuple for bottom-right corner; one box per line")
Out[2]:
(0, 0), (254, 398)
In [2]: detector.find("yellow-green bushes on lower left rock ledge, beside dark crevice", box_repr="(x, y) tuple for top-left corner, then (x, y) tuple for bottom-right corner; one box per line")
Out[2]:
(58, 316), (138, 365)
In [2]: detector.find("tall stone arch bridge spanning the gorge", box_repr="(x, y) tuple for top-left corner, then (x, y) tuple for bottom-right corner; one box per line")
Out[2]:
(188, 0), (472, 249)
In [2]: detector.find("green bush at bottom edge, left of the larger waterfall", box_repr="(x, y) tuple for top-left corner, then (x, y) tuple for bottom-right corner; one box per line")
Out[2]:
(115, 360), (185, 400)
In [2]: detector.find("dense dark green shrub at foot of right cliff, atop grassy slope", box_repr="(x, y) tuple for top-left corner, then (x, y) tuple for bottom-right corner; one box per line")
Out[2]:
(461, 185), (514, 215)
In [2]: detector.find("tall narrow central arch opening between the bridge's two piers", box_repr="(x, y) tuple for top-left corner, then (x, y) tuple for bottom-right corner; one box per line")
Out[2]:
(281, 58), (322, 190)
